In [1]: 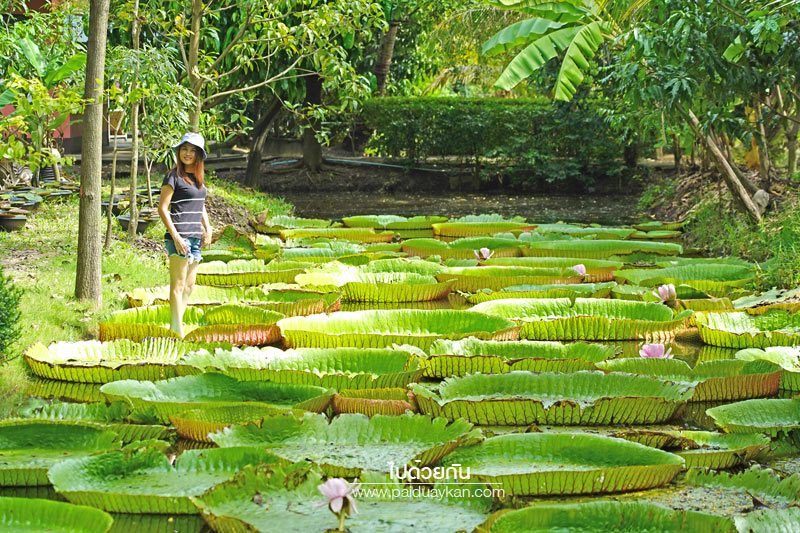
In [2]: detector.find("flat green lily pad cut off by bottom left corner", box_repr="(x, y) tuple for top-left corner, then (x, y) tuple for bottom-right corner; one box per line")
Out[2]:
(0, 498), (113, 533)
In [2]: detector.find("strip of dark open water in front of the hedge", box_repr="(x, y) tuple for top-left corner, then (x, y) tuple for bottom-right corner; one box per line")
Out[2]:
(282, 191), (642, 225)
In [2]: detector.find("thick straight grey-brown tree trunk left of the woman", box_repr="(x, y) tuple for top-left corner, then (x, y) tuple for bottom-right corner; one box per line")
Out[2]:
(75, 0), (109, 307)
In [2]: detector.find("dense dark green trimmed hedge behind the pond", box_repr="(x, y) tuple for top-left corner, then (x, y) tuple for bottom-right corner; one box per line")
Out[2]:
(363, 97), (621, 186)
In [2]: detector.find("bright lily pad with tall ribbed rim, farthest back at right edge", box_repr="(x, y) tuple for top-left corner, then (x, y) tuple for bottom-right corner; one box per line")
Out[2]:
(695, 309), (800, 349)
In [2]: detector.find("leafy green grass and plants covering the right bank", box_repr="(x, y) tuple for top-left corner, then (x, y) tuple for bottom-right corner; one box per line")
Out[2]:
(687, 195), (800, 290)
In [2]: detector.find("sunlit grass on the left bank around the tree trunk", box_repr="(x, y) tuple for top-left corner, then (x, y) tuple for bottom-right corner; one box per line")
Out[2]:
(0, 180), (292, 415)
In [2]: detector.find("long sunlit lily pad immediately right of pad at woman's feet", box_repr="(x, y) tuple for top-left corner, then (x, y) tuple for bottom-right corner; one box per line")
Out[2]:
(278, 310), (518, 350)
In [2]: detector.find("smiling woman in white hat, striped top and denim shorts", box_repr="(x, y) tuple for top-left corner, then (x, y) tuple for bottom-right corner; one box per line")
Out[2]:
(158, 133), (211, 337)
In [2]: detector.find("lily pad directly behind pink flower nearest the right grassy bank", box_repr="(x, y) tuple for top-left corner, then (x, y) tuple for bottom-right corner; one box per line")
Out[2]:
(616, 264), (755, 297)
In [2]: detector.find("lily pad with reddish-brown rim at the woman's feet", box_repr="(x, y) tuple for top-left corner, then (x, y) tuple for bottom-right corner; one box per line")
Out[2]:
(100, 304), (284, 346)
